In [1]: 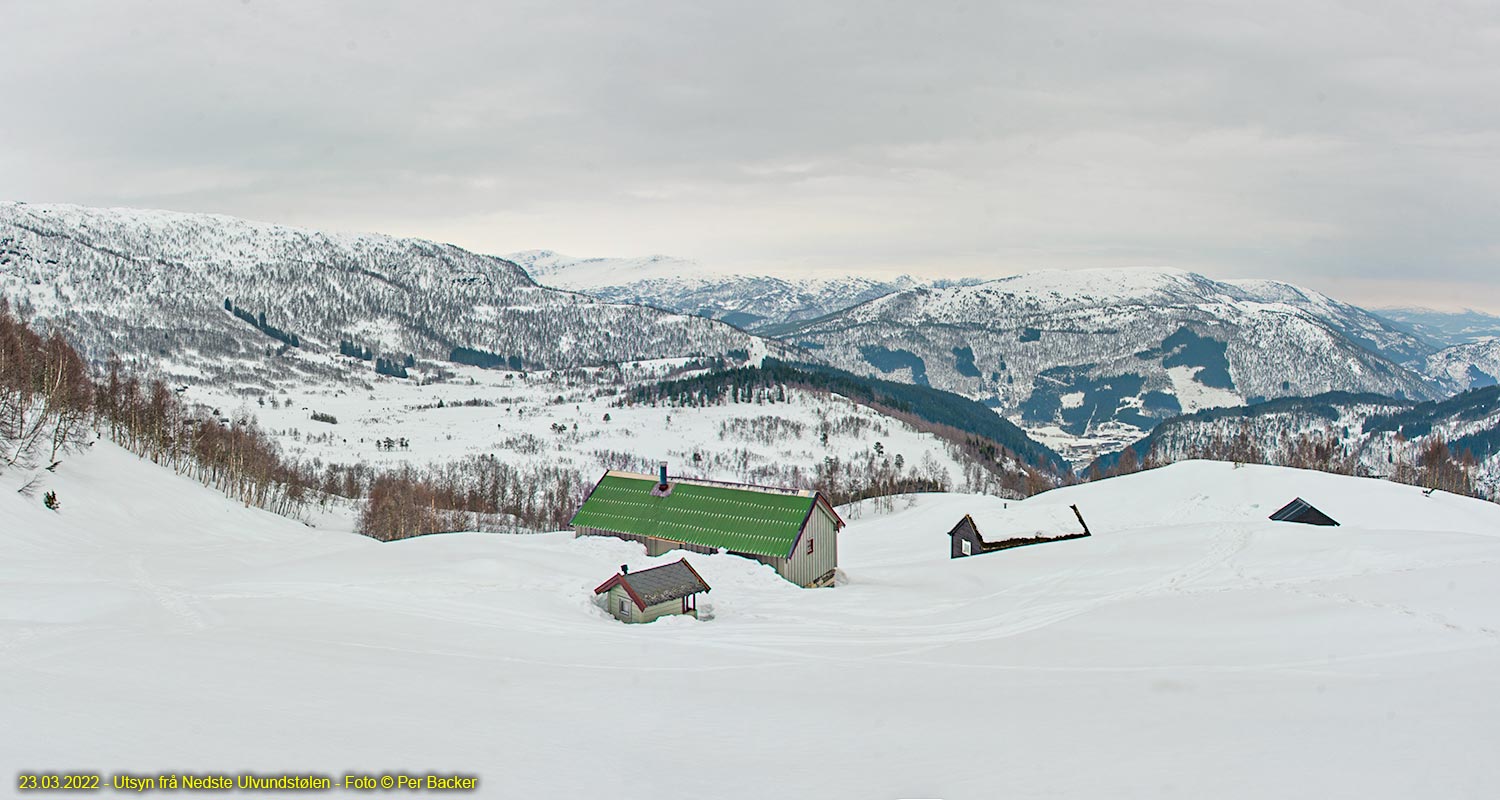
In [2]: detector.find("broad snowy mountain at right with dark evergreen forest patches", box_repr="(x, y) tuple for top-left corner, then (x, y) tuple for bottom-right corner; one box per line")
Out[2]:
(785, 269), (1442, 459)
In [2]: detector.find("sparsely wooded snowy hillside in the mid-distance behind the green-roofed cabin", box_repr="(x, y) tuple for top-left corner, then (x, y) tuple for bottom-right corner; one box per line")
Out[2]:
(172, 354), (1032, 516)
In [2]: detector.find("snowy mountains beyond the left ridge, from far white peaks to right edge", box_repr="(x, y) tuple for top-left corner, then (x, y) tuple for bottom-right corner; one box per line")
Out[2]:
(509, 251), (1464, 459)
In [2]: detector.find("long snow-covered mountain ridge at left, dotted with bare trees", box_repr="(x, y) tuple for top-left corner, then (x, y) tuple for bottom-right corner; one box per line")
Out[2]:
(0, 203), (774, 382)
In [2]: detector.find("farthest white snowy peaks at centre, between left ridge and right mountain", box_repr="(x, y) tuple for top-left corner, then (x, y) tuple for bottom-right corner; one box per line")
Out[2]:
(506, 251), (918, 332)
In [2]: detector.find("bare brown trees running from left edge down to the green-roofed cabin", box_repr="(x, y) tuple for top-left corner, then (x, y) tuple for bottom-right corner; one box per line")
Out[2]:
(0, 297), (588, 540)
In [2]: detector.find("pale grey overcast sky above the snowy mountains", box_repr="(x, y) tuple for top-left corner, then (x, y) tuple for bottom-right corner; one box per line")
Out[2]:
(0, 0), (1500, 312)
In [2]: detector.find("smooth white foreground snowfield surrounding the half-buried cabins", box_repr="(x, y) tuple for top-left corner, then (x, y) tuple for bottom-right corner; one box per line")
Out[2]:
(0, 443), (1500, 800)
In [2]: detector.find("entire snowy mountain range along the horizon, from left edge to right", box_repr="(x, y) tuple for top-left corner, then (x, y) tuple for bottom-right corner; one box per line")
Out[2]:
(0, 203), (1500, 462)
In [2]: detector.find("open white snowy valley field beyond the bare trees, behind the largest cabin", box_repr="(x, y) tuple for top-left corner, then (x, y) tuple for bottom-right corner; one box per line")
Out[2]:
(183, 353), (966, 488)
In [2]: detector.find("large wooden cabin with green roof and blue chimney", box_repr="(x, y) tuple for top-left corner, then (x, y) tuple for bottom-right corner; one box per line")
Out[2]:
(572, 464), (845, 587)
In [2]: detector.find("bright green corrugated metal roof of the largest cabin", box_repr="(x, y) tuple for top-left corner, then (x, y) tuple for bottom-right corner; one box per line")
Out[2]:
(572, 471), (818, 555)
